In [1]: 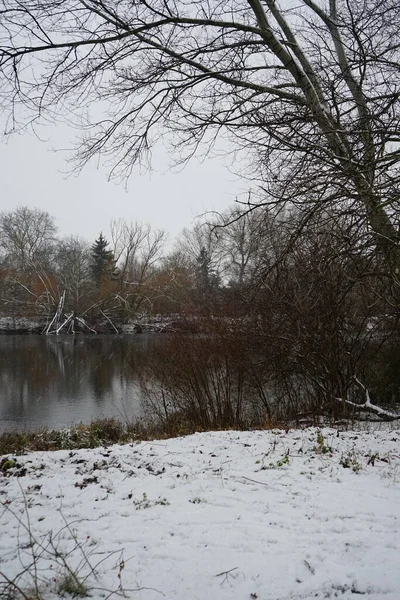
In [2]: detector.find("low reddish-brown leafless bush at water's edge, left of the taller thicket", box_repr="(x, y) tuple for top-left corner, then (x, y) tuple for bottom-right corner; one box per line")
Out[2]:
(142, 328), (252, 429)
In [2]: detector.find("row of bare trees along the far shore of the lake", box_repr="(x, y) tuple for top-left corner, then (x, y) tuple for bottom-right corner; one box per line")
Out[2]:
(0, 206), (280, 322)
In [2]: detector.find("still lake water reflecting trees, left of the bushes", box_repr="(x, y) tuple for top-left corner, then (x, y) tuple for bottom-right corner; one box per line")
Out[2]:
(0, 334), (159, 432)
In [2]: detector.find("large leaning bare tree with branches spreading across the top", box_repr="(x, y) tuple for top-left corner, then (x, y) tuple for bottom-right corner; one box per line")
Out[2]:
(0, 0), (400, 280)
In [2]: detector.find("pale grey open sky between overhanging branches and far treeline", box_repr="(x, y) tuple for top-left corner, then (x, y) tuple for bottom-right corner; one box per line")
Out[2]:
(0, 126), (249, 247)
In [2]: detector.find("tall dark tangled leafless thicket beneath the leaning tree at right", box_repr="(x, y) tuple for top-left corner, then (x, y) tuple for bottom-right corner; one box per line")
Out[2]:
(241, 210), (398, 416)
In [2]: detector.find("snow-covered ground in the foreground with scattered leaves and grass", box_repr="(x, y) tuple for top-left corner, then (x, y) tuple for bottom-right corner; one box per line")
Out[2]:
(0, 426), (400, 600)
